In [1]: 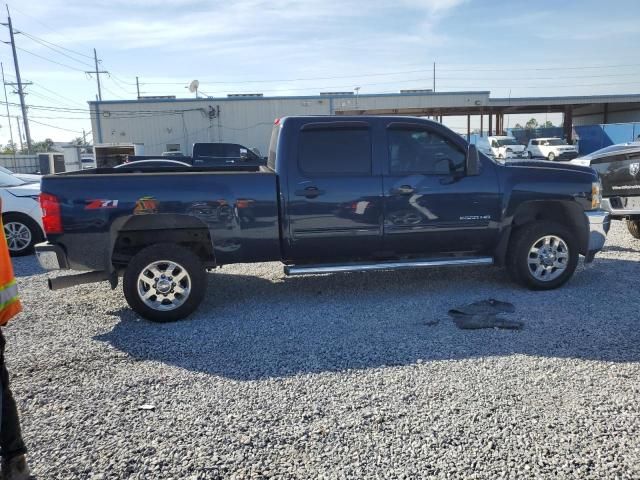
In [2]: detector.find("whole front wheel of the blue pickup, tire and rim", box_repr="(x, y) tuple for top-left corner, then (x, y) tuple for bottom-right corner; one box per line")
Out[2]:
(507, 220), (578, 290)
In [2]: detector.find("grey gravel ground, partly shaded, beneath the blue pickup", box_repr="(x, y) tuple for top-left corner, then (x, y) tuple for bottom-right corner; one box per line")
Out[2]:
(5, 222), (640, 479)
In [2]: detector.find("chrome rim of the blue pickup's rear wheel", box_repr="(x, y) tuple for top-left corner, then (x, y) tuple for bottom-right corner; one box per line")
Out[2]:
(138, 260), (191, 312)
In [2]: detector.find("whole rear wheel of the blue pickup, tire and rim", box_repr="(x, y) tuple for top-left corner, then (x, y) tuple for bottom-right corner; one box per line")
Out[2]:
(122, 243), (207, 323)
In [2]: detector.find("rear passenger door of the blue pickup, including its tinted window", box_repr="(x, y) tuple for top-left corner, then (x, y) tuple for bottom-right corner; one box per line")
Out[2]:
(286, 121), (383, 263)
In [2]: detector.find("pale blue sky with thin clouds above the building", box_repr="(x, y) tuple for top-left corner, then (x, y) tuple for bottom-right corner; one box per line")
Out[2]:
(0, 0), (640, 144)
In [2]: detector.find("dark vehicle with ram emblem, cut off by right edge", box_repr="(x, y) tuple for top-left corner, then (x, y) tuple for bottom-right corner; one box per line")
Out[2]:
(572, 142), (640, 239)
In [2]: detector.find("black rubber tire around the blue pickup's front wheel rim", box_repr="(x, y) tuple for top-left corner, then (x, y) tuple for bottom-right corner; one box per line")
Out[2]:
(506, 220), (579, 290)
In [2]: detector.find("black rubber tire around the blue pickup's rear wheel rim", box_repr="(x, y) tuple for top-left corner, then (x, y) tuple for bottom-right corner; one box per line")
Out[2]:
(122, 243), (207, 323)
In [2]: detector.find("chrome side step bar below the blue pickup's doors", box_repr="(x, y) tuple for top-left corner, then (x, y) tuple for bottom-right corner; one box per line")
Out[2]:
(284, 257), (493, 276)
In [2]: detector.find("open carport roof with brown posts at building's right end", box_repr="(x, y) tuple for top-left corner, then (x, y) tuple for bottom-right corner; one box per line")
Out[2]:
(334, 92), (640, 142)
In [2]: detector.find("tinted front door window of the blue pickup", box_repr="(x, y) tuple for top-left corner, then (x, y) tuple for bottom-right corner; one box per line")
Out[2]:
(388, 129), (465, 175)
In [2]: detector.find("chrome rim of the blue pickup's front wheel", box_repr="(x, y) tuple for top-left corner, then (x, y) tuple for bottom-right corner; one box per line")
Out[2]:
(527, 235), (569, 282)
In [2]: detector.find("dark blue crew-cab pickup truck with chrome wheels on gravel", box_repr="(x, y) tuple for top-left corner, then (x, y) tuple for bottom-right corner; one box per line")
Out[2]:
(36, 116), (609, 321)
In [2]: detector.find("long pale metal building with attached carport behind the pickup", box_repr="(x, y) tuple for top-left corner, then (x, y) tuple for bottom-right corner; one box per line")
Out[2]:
(89, 90), (640, 155)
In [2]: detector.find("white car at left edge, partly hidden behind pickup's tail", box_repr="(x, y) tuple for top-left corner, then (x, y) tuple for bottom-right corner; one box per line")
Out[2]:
(0, 172), (44, 256)
